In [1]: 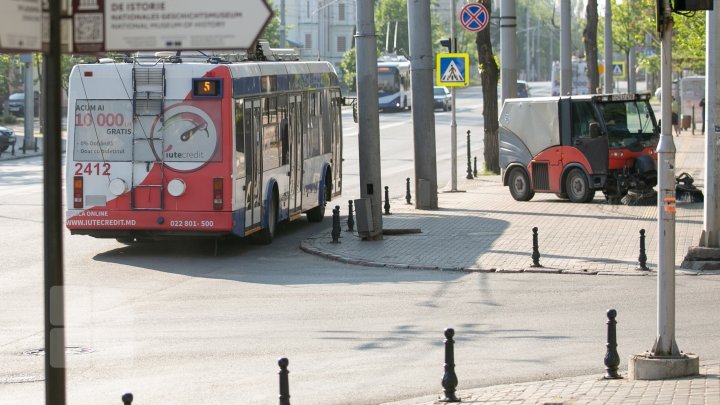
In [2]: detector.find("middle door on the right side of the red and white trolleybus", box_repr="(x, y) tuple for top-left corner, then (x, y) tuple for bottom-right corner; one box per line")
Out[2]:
(288, 94), (302, 219)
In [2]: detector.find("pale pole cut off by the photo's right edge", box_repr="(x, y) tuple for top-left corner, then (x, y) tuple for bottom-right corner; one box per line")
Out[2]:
(700, 7), (720, 248)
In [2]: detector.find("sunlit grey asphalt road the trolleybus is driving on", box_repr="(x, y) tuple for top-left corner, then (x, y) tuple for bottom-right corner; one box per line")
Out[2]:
(0, 84), (720, 405)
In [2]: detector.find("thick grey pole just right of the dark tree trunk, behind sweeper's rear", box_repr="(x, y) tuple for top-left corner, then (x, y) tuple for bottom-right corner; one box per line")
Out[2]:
(500, 0), (516, 102)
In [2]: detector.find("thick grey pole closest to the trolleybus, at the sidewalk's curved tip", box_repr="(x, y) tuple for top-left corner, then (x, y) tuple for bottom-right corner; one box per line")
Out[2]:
(355, 0), (382, 240)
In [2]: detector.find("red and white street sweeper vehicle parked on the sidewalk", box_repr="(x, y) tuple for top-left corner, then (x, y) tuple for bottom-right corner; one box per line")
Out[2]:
(498, 94), (660, 205)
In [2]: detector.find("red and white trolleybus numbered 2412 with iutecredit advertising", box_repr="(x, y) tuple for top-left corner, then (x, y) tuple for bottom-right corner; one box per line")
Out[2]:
(66, 43), (342, 243)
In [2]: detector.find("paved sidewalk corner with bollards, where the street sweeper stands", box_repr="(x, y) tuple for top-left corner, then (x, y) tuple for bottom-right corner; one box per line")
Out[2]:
(301, 132), (712, 276)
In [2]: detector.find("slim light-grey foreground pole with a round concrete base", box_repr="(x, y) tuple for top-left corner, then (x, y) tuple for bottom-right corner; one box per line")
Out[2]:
(632, 0), (700, 380)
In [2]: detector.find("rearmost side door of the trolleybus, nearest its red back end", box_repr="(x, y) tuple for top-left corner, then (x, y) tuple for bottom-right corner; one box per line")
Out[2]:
(245, 100), (262, 234)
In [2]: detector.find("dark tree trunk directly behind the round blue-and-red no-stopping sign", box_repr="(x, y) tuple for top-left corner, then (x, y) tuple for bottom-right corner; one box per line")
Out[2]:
(475, 0), (500, 174)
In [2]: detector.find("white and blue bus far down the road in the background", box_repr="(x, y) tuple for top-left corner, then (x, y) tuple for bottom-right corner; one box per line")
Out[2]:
(377, 55), (412, 110)
